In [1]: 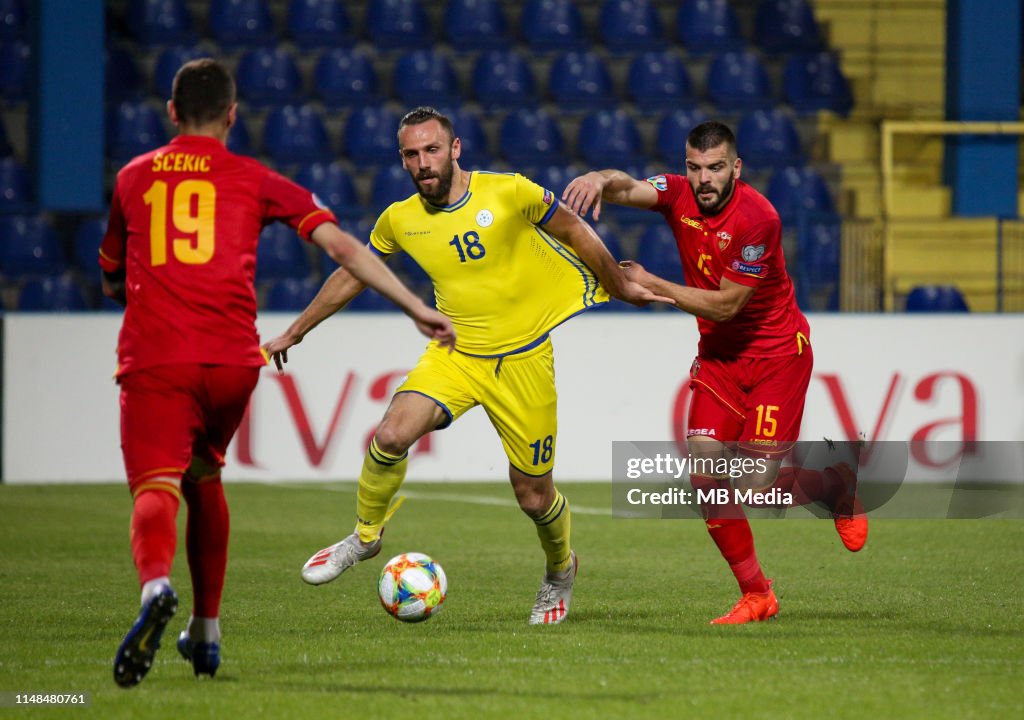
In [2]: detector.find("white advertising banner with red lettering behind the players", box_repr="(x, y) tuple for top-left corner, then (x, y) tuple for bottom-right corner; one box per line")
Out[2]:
(2, 312), (1024, 482)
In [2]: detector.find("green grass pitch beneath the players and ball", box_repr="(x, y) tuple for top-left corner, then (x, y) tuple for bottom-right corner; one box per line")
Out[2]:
(0, 483), (1024, 720)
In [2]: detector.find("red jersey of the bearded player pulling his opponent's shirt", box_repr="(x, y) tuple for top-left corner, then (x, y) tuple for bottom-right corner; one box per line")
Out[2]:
(647, 175), (810, 357)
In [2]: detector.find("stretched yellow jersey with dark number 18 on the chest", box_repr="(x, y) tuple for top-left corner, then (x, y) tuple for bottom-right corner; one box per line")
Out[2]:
(370, 171), (608, 357)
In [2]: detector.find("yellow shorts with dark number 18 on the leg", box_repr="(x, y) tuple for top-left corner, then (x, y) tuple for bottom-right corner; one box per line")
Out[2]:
(395, 338), (558, 476)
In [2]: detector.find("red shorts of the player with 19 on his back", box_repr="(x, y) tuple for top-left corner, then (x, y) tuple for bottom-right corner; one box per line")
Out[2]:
(120, 365), (260, 494)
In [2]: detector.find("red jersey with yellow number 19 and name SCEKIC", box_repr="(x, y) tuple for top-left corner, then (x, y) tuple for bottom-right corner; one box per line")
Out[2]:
(99, 135), (335, 375)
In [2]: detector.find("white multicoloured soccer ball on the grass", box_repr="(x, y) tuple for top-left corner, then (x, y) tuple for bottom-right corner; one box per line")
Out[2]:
(377, 552), (447, 623)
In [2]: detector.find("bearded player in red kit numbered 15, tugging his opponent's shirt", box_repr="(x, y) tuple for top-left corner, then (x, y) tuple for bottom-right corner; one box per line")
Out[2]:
(562, 121), (867, 625)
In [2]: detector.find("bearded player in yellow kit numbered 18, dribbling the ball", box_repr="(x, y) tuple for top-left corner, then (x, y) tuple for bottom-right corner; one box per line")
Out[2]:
(265, 108), (665, 625)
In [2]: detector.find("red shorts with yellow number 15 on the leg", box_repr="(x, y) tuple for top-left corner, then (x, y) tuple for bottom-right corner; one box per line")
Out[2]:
(686, 345), (814, 457)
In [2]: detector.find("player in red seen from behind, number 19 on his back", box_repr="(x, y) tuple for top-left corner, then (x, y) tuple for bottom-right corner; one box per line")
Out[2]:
(99, 58), (454, 687)
